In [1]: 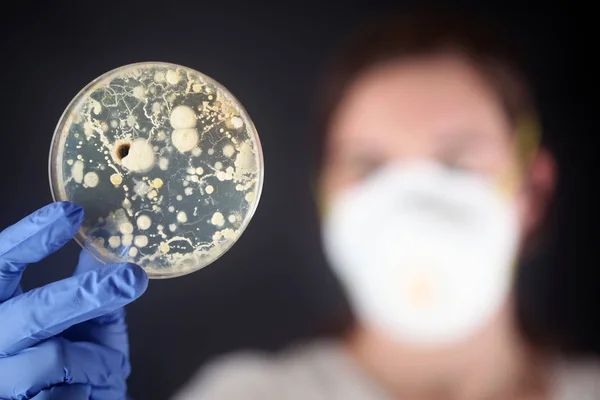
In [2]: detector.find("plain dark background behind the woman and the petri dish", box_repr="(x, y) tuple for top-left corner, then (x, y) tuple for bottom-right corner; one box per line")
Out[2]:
(0, 0), (600, 399)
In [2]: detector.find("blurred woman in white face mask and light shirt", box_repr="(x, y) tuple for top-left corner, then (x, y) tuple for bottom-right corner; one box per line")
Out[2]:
(176, 12), (600, 400)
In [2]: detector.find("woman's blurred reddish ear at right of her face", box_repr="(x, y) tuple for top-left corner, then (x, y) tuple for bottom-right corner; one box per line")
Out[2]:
(524, 147), (557, 236)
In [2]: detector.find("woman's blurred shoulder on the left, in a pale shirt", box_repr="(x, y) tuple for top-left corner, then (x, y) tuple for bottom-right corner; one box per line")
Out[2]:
(169, 341), (378, 400)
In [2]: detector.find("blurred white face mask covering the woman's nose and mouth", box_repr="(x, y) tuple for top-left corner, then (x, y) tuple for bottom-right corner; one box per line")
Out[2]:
(323, 161), (519, 344)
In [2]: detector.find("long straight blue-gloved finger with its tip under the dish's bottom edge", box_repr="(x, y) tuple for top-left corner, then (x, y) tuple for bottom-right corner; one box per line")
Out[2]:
(0, 263), (148, 357)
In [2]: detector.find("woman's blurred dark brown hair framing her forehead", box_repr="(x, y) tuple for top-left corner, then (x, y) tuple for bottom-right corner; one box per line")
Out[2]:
(314, 12), (537, 171)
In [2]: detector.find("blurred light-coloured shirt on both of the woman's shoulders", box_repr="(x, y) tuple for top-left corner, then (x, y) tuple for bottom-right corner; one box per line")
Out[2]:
(173, 341), (600, 400)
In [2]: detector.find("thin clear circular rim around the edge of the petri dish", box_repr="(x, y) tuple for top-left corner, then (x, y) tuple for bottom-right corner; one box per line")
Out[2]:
(48, 61), (264, 279)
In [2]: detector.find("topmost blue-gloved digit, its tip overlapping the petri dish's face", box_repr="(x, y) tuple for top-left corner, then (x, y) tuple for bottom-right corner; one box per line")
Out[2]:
(0, 202), (83, 303)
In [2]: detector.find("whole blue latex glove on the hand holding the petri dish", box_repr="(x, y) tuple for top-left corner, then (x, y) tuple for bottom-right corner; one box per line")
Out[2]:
(0, 202), (148, 400)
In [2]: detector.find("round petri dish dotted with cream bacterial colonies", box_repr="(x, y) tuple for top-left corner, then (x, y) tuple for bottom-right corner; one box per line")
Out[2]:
(49, 62), (264, 278)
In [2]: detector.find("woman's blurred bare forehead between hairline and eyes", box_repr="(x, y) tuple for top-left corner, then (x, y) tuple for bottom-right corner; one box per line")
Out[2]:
(330, 56), (509, 149)
